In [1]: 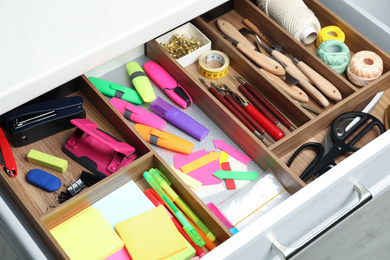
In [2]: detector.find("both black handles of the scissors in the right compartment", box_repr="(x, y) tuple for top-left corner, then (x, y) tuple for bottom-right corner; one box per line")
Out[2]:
(287, 111), (385, 182)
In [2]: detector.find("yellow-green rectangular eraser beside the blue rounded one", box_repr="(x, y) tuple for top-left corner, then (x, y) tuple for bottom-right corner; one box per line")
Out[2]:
(27, 149), (68, 173)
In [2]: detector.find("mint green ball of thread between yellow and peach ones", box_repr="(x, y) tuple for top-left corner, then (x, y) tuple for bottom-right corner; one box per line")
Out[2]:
(316, 40), (351, 74)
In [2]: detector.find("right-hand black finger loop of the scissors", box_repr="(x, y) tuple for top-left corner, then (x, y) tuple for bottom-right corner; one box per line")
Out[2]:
(331, 111), (385, 152)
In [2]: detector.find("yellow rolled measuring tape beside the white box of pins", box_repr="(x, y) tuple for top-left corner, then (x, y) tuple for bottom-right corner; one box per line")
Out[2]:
(198, 50), (230, 79)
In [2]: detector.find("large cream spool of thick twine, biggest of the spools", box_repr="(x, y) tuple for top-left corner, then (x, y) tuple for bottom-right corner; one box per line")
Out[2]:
(256, 0), (321, 44)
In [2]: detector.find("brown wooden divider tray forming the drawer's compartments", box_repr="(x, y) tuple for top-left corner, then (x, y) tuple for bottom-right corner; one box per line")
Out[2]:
(0, 0), (390, 259)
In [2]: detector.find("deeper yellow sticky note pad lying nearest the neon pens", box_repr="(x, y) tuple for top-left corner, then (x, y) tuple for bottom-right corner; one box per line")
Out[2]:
(115, 206), (187, 260)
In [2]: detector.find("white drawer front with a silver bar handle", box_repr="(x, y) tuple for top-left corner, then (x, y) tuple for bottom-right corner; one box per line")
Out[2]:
(205, 132), (390, 260)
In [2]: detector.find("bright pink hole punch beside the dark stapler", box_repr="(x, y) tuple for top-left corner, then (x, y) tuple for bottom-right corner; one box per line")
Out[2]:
(62, 119), (137, 178)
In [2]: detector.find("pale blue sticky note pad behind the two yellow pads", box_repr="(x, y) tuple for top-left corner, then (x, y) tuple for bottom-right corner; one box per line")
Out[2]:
(92, 181), (155, 229)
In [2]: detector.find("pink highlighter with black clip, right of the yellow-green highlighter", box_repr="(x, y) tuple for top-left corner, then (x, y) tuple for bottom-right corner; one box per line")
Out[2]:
(144, 61), (192, 108)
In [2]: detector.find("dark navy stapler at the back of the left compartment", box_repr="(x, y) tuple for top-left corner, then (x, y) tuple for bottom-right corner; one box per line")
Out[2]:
(5, 96), (86, 146)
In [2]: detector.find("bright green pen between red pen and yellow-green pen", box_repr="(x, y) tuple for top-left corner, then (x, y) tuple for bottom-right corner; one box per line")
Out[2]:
(143, 172), (205, 247)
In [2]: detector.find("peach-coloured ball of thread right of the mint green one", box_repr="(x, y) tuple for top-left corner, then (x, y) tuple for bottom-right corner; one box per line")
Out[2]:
(347, 51), (383, 87)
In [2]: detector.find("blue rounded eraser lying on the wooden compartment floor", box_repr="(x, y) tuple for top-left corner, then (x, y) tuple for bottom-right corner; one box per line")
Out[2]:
(26, 169), (61, 192)
